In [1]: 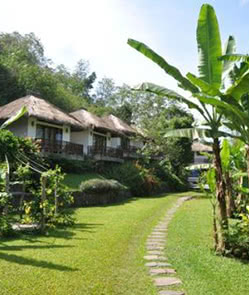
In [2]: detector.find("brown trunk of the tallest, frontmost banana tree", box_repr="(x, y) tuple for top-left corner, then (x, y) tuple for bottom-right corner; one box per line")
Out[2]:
(213, 138), (228, 253)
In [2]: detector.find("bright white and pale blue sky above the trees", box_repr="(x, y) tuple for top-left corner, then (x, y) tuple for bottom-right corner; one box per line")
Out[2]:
(0, 0), (249, 97)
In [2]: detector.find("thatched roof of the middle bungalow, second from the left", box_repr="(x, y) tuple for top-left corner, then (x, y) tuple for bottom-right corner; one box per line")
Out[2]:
(70, 109), (118, 133)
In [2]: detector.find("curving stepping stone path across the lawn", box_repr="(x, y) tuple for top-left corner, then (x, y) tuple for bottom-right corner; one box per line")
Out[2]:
(144, 197), (192, 295)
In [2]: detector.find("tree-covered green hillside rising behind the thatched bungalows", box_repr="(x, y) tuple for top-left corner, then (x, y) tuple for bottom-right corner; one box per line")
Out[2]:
(0, 32), (194, 176)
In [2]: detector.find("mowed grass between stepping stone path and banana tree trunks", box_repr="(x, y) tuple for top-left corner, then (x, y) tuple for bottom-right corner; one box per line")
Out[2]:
(166, 199), (249, 295)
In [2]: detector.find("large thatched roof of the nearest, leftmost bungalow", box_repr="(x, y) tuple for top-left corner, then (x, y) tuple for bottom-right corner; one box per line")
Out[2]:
(0, 95), (83, 129)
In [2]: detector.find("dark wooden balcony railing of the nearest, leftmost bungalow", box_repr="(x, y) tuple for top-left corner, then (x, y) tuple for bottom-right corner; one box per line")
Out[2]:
(36, 138), (83, 156)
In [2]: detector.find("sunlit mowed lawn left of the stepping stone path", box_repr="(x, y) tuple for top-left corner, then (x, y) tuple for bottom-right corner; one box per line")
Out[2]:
(0, 194), (186, 295)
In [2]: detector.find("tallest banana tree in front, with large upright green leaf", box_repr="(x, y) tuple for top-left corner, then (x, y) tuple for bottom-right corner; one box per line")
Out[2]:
(128, 4), (242, 253)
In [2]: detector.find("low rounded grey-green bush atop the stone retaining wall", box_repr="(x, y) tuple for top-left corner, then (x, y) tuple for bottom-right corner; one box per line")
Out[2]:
(80, 179), (127, 194)
